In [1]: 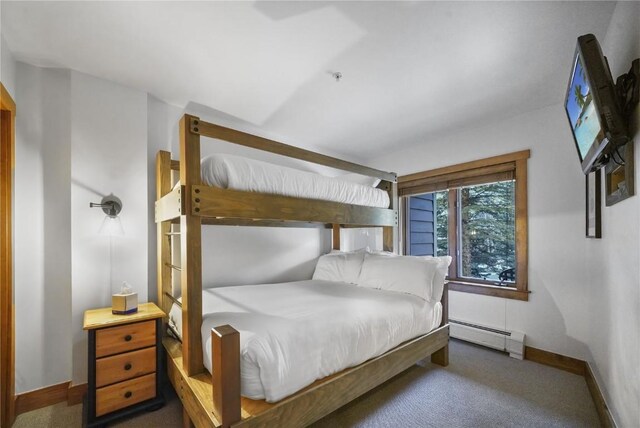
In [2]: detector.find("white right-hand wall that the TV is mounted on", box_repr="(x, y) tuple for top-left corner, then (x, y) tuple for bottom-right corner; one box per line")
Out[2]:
(584, 2), (640, 427)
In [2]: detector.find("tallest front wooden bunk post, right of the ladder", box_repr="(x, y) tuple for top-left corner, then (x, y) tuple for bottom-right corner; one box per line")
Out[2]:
(180, 114), (204, 376)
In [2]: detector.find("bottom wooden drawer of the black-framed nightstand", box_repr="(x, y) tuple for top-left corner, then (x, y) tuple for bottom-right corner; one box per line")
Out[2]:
(96, 373), (156, 416)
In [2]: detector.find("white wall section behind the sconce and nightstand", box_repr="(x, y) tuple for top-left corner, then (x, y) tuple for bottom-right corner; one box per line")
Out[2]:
(71, 72), (149, 383)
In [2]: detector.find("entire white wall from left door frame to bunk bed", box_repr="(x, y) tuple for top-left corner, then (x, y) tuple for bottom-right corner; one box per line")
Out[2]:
(15, 63), (148, 393)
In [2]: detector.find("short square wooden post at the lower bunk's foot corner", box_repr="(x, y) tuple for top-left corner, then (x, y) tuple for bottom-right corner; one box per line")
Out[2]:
(211, 325), (241, 428)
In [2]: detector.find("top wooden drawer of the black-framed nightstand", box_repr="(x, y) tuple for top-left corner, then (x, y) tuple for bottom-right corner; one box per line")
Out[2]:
(96, 321), (156, 358)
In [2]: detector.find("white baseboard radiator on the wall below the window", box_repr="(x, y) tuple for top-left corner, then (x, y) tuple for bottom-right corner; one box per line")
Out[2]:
(449, 319), (525, 360)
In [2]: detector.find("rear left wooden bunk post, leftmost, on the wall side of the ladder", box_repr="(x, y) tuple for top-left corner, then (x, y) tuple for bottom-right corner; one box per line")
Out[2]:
(156, 151), (172, 314)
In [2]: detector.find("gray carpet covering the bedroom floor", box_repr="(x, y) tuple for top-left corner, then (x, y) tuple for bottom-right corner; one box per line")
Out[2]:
(14, 340), (600, 428)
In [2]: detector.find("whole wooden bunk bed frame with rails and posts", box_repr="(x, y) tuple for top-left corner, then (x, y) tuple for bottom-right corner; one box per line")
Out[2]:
(155, 115), (449, 427)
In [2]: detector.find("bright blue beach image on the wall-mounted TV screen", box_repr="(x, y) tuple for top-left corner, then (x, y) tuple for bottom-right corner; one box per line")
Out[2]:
(566, 55), (602, 160)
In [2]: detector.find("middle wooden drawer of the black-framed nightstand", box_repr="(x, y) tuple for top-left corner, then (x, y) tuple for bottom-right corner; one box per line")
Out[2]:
(96, 346), (156, 388)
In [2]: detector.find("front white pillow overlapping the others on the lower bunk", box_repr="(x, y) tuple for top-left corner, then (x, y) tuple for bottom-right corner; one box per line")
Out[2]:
(358, 253), (448, 302)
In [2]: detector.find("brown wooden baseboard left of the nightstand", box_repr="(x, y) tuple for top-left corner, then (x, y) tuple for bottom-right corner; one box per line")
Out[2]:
(15, 381), (87, 415)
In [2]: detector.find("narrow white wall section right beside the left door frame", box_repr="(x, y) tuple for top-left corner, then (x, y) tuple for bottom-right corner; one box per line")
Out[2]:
(14, 63), (71, 393)
